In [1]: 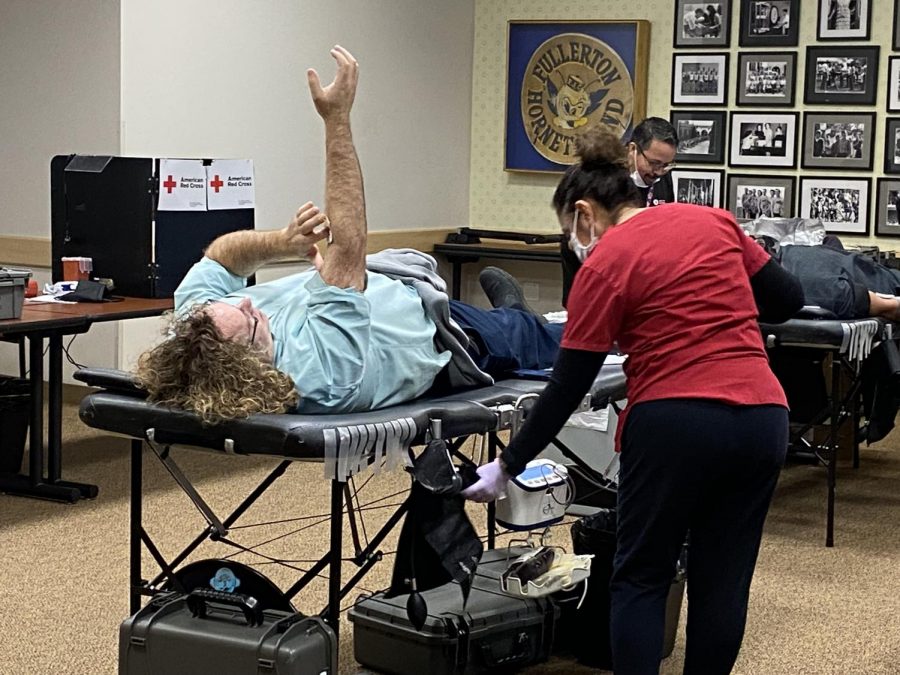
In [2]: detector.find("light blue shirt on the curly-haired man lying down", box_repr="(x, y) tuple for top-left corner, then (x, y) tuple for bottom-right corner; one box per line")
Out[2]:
(175, 257), (450, 413)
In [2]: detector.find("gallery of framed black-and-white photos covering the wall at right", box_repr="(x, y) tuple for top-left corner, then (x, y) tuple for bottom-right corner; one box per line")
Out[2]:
(672, 0), (900, 243)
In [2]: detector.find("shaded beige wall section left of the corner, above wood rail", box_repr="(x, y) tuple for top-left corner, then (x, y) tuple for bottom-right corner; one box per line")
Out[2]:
(0, 0), (120, 242)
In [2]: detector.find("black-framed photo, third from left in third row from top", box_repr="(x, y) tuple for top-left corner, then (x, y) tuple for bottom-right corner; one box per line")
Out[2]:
(800, 112), (875, 171)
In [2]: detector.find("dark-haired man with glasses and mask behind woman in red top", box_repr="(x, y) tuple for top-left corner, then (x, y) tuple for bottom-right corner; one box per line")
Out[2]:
(560, 117), (678, 307)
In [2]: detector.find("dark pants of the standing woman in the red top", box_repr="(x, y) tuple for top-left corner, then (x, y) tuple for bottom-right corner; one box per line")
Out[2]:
(610, 399), (788, 675)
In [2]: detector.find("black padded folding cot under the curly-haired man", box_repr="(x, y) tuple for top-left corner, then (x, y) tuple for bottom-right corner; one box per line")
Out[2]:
(76, 364), (625, 648)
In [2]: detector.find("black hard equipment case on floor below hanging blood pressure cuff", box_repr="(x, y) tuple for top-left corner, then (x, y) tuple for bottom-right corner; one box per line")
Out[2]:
(349, 549), (559, 675)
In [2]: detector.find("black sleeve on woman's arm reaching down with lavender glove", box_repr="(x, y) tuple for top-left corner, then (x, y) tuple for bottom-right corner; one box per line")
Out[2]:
(501, 349), (606, 476)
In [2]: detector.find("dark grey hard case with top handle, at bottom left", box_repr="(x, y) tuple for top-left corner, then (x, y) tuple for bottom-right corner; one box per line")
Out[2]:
(119, 589), (338, 675)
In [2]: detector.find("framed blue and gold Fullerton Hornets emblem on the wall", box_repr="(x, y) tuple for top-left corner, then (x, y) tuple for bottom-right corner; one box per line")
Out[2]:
(503, 20), (650, 174)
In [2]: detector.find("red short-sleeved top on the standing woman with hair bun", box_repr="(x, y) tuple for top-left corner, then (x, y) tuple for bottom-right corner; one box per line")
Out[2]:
(562, 204), (787, 448)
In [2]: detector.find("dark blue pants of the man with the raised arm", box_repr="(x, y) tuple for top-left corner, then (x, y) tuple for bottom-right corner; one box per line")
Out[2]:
(450, 300), (565, 375)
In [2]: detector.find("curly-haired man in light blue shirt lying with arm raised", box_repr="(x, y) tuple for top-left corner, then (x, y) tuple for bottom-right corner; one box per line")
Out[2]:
(137, 46), (562, 423)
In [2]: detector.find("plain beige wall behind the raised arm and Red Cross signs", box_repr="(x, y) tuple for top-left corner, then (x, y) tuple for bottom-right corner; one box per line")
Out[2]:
(0, 0), (474, 372)
